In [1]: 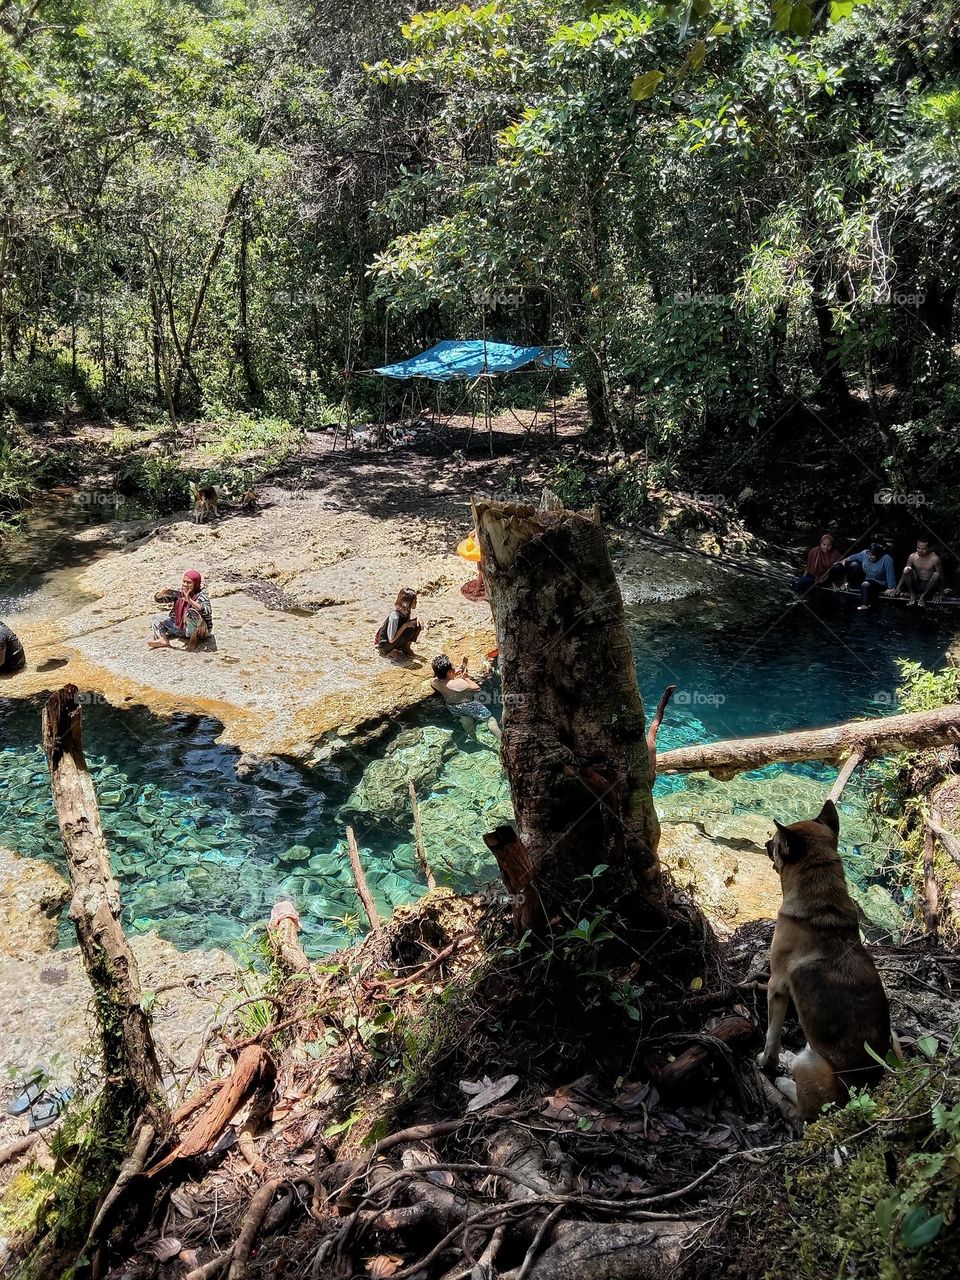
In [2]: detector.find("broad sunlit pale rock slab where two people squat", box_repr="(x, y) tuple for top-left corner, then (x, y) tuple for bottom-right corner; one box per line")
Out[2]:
(9, 492), (494, 759)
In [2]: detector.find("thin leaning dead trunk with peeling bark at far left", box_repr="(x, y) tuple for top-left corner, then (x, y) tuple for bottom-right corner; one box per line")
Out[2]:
(44, 685), (169, 1137)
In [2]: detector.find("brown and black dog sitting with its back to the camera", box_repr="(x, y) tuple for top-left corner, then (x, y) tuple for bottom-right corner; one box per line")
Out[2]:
(758, 800), (891, 1120)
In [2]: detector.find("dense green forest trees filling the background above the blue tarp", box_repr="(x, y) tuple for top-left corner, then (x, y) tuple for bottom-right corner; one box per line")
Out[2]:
(0, 0), (960, 504)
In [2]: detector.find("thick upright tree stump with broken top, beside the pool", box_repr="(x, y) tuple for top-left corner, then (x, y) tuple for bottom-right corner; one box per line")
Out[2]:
(474, 500), (663, 920)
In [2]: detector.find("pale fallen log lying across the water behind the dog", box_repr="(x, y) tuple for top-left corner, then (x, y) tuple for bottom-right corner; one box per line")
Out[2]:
(657, 704), (960, 782)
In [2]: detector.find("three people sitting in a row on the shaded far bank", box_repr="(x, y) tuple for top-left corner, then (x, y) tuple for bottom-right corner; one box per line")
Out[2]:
(794, 534), (943, 609)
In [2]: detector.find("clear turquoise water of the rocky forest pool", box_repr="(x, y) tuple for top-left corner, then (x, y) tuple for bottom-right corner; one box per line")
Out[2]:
(0, 582), (950, 955)
